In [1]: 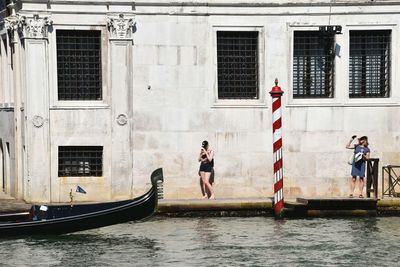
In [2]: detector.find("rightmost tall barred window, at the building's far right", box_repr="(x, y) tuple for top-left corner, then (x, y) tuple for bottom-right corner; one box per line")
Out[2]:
(349, 30), (391, 98)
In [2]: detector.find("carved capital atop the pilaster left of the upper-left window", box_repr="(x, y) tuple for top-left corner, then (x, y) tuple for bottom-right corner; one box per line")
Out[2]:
(21, 14), (53, 39)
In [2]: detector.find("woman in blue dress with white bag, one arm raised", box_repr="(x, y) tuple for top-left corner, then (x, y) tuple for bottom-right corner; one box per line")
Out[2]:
(346, 135), (370, 198)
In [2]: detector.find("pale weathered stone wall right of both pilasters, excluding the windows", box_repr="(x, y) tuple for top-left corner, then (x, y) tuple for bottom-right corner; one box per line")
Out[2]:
(129, 6), (400, 198)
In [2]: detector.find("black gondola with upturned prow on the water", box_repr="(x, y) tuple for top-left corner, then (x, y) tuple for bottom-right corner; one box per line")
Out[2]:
(0, 168), (164, 237)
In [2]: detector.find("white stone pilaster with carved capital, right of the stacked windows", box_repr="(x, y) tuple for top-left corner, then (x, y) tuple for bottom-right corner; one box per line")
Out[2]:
(107, 14), (135, 198)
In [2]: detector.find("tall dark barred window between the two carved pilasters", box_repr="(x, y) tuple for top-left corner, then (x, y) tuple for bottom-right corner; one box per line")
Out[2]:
(56, 30), (102, 100)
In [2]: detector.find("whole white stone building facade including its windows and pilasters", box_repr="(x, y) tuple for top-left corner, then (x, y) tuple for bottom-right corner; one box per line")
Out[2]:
(0, 0), (400, 202)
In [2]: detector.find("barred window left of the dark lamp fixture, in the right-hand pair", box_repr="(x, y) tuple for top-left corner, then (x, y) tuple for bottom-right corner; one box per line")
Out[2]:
(293, 31), (335, 98)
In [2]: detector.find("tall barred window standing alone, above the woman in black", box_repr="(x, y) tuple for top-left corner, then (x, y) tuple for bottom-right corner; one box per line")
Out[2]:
(217, 31), (259, 99)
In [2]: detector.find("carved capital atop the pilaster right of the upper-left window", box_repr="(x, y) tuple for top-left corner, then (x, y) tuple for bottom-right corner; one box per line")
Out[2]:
(107, 14), (136, 40)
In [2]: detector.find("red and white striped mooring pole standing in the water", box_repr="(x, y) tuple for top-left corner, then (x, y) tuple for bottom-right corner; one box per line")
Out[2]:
(269, 79), (284, 217)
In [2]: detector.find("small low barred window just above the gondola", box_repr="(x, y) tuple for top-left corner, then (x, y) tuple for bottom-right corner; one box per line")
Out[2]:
(58, 146), (103, 177)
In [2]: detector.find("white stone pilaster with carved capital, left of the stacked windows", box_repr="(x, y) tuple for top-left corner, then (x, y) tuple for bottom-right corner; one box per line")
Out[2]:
(20, 14), (52, 202)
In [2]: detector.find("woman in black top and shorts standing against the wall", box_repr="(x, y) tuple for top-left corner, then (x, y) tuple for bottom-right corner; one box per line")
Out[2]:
(199, 141), (215, 199)
